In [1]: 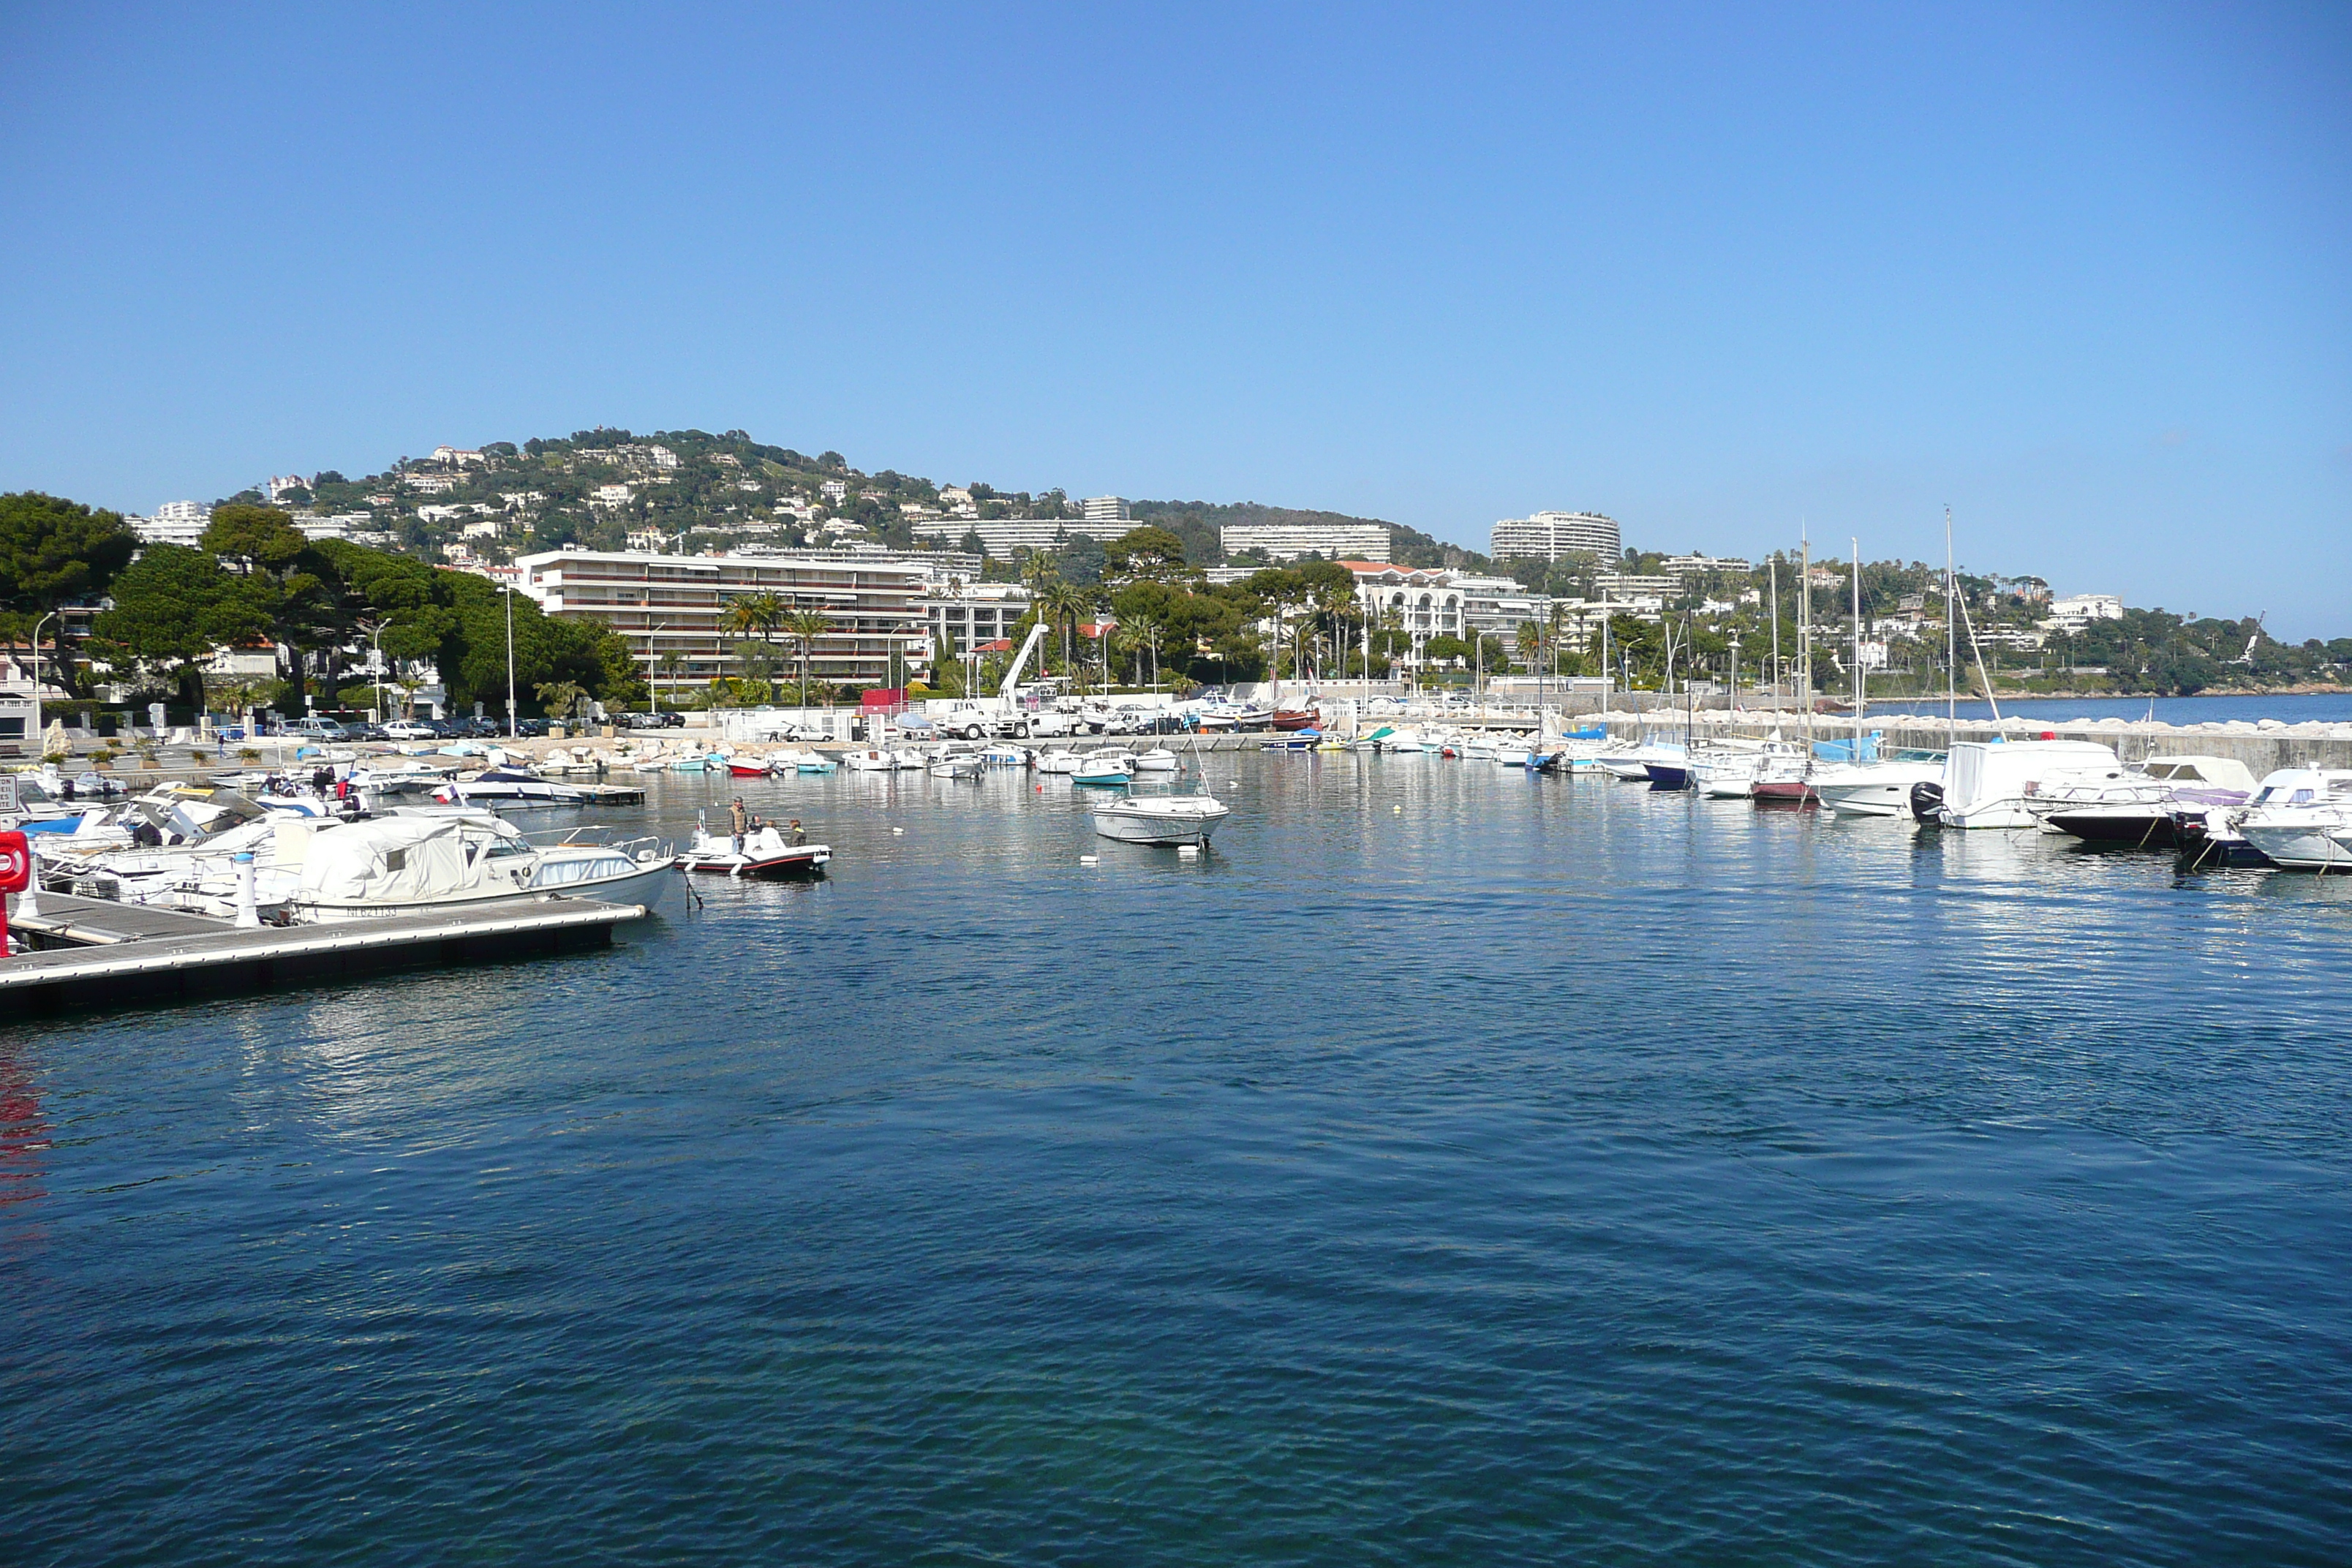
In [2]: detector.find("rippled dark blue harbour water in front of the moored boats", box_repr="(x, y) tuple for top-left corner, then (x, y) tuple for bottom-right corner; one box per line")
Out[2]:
(0, 757), (2352, 1564)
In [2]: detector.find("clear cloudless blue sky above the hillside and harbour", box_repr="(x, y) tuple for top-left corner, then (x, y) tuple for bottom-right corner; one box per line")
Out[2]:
(0, 4), (2352, 637)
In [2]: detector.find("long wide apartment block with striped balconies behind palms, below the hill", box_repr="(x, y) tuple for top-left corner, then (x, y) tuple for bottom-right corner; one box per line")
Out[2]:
(515, 550), (929, 687)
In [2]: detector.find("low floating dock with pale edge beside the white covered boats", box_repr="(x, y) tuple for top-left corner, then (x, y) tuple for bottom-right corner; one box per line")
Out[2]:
(0, 893), (644, 1018)
